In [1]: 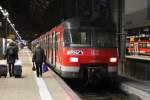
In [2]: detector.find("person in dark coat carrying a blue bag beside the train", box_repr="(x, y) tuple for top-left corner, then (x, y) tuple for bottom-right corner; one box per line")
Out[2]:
(32, 44), (46, 77)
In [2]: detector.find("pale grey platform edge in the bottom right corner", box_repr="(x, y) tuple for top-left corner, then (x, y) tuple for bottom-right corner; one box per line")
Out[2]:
(121, 78), (150, 100)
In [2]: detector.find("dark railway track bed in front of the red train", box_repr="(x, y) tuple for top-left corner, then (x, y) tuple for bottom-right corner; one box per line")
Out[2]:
(66, 81), (141, 100)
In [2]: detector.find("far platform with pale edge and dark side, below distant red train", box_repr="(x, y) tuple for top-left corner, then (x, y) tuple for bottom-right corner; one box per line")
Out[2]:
(124, 55), (150, 81)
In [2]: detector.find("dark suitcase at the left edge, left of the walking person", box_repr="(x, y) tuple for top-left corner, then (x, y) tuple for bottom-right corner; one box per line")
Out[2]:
(0, 60), (7, 78)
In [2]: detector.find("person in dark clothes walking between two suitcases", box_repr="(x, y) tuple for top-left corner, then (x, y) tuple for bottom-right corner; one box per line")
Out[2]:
(4, 42), (18, 77)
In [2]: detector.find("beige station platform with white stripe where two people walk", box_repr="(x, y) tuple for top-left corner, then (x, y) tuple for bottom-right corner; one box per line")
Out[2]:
(0, 48), (81, 100)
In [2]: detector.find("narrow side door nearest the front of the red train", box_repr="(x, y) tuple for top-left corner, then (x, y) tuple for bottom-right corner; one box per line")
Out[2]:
(51, 32), (56, 66)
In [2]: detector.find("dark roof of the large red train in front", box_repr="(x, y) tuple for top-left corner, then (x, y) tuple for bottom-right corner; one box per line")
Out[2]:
(32, 18), (116, 43)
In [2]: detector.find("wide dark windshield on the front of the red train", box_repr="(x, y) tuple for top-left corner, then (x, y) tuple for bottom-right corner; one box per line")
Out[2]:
(64, 29), (116, 48)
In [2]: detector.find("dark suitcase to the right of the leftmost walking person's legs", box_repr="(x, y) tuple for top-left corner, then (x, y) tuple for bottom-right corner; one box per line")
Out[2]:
(13, 60), (22, 78)
